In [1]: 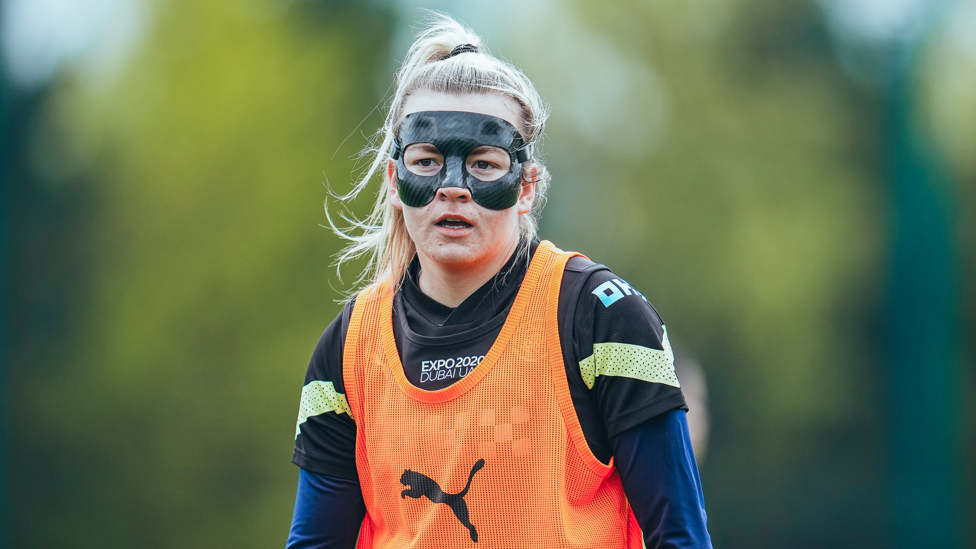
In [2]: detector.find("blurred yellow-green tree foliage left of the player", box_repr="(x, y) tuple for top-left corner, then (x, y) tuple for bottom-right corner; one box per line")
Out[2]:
(11, 0), (390, 548)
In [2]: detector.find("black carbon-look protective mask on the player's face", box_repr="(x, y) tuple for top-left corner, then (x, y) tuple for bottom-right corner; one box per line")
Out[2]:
(391, 111), (532, 210)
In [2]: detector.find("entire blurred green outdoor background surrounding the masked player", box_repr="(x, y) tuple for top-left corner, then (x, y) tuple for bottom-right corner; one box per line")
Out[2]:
(0, 0), (976, 549)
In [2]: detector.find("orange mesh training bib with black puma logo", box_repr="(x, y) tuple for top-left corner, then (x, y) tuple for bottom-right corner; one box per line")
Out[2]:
(343, 242), (642, 549)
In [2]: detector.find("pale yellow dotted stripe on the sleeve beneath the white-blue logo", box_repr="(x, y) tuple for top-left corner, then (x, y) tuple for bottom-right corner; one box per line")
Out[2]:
(580, 328), (681, 389)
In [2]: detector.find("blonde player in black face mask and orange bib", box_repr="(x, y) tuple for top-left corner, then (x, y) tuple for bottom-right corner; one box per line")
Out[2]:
(288, 15), (711, 549)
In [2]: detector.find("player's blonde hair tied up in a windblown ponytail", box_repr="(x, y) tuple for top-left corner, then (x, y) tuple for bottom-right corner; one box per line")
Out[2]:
(326, 12), (551, 296)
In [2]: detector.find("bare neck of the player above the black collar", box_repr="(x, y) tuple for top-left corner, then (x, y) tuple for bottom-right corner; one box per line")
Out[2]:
(417, 238), (519, 307)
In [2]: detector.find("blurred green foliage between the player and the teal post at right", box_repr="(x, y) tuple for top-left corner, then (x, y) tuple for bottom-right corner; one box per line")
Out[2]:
(545, 0), (886, 548)
